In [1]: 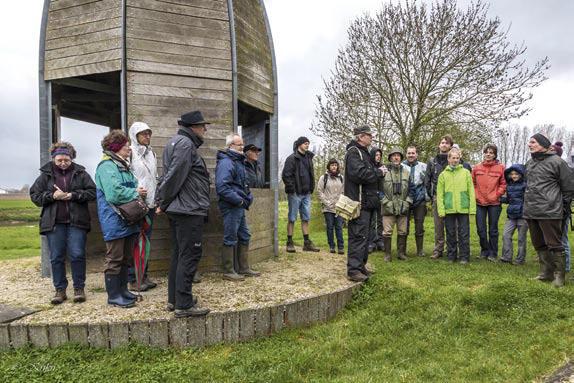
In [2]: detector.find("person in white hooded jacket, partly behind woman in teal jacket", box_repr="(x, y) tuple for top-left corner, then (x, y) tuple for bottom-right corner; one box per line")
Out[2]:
(128, 122), (157, 291)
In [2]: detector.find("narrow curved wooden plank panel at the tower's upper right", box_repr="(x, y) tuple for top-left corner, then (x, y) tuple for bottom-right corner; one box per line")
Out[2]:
(233, 0), (274, 114)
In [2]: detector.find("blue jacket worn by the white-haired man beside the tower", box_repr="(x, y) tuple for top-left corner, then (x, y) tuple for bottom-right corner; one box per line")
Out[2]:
(215, 150), (253, 212)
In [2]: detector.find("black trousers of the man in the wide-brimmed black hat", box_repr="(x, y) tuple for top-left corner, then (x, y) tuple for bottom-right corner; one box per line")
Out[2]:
(167, 214), (204, 310)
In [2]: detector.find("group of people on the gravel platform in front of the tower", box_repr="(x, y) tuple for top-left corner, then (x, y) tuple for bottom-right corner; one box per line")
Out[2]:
(30, 111), (265, 317)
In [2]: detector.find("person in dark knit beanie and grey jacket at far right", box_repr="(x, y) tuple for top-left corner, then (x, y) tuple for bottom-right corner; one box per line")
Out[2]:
(523, 133), (574, 287)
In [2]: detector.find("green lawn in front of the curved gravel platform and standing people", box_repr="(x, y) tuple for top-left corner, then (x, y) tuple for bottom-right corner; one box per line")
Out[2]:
(0, 200), (574, 382)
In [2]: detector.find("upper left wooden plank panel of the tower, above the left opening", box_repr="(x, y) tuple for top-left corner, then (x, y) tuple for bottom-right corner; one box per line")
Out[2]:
(44, 0), (122, 80)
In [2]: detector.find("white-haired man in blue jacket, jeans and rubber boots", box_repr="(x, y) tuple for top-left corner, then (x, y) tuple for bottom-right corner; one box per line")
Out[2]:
(215, 133), (260, 281)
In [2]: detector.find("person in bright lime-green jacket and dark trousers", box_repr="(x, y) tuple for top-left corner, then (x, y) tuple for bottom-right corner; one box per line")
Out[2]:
(436, 148), (476, 264)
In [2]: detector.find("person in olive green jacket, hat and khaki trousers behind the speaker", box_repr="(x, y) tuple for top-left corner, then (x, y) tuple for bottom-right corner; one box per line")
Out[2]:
(381, 148), (412, 262)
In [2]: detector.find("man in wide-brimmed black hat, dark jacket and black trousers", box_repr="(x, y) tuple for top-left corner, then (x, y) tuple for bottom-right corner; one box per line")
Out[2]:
(158, 111), (210, 317)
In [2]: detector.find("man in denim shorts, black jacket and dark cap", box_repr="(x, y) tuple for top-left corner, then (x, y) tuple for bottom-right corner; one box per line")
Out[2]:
(281, 137), (319, 253)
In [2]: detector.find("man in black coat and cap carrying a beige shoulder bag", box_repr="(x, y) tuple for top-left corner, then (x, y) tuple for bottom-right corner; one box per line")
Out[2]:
(344, 126), (386, 282)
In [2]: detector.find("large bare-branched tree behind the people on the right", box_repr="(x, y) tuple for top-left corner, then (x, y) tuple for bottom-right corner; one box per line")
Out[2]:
(312, 0), (548, 160)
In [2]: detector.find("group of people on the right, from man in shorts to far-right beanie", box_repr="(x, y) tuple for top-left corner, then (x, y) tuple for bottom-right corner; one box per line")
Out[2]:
(282, 126), (574, 287)
